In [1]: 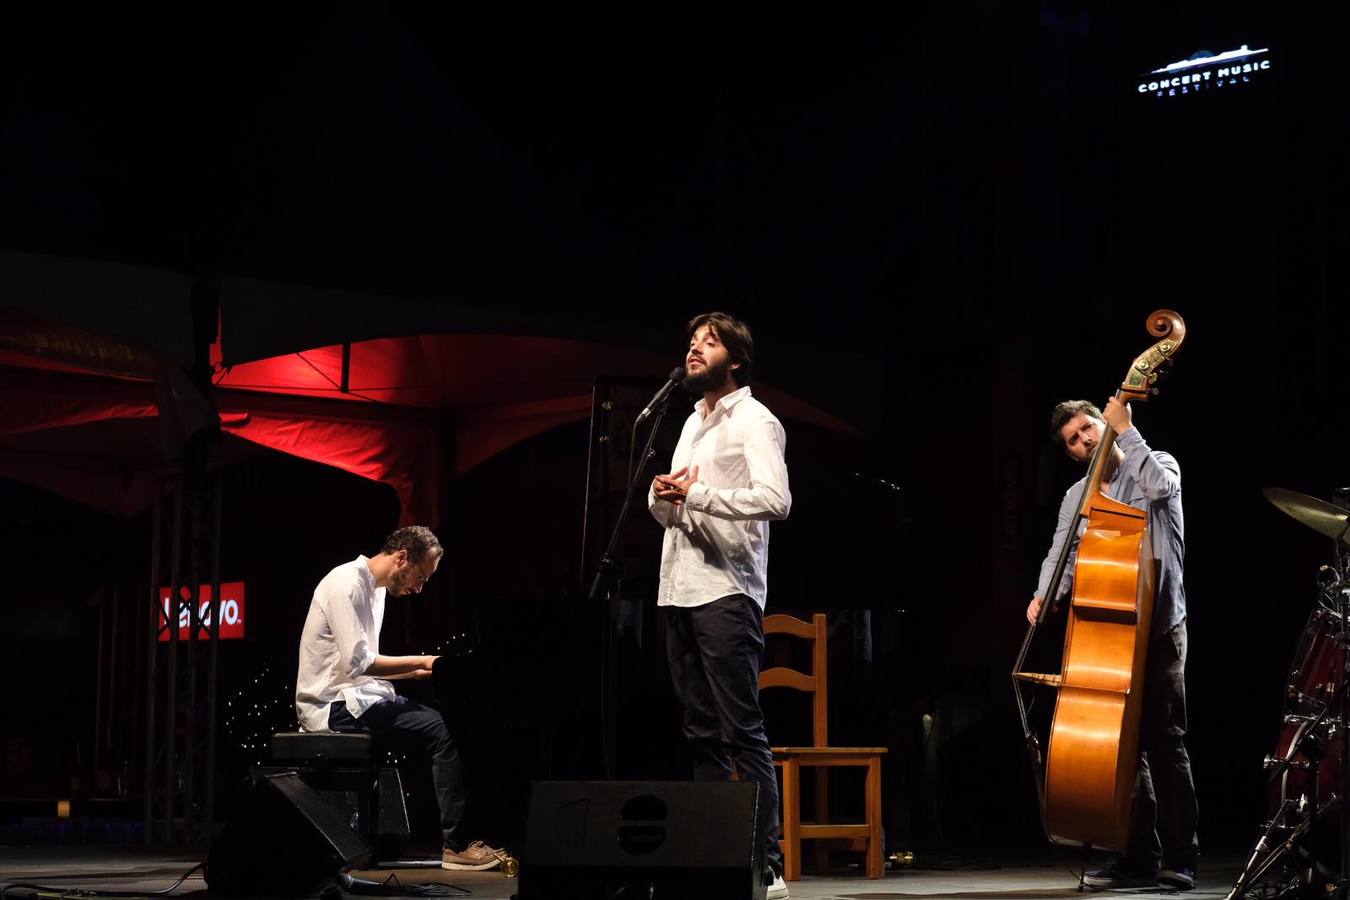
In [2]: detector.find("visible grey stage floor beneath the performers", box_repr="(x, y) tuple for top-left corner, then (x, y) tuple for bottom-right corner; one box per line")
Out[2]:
(0, 847), (1239, 900)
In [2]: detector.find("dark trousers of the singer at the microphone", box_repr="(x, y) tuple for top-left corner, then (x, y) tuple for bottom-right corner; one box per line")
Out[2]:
(662, 594), (783, 874)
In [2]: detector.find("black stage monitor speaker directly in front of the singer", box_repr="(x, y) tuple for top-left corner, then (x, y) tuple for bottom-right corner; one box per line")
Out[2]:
(520, 781), (767, 900)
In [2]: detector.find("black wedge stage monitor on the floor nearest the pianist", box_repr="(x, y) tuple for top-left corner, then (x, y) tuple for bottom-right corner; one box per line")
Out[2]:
(205, 772), (370, 897)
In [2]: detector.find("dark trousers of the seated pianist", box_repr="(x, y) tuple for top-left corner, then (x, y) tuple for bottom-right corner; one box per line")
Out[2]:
(328, 696), (467, 851)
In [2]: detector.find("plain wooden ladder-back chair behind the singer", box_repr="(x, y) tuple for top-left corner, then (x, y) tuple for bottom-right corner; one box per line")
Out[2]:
(760, 613), (886, 881)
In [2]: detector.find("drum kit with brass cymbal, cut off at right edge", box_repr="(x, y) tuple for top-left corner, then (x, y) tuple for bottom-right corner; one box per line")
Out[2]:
(1227, 487), (1350, 900)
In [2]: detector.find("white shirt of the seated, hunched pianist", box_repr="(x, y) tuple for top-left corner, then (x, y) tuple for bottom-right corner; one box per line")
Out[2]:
(296, 556), (397, 731)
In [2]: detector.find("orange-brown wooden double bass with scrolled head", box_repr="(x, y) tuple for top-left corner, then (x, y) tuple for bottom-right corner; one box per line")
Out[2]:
(1013, 309), (1185, 850)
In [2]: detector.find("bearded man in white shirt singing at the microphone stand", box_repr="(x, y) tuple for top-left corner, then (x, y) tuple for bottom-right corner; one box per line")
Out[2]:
(648, 313), (792, 900)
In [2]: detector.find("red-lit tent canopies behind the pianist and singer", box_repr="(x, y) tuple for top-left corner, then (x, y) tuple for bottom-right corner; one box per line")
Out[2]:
(0, 335), (857, 524)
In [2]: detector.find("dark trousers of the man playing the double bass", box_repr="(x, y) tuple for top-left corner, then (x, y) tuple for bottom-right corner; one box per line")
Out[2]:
(1125, 621), (1200, 869)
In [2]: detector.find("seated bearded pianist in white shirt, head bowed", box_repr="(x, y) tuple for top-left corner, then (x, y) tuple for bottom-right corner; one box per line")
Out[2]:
(296, 525), (500, 869)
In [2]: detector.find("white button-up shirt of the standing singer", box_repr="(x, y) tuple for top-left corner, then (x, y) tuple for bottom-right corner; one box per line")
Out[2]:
(647, 386), (792, 609)
